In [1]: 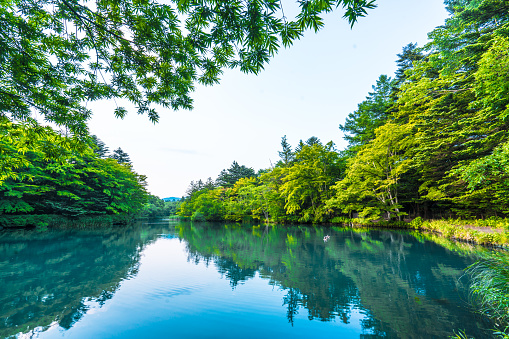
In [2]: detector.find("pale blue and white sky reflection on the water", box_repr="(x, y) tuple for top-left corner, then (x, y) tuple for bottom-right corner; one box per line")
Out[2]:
(35, 238), (366, 338)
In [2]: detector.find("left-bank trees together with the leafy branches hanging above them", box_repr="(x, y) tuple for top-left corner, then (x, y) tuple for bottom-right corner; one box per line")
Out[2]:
(0, 0), (376, 229)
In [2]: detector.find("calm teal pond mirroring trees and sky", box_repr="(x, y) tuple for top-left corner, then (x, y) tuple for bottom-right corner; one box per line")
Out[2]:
(0, 220), (493, 338)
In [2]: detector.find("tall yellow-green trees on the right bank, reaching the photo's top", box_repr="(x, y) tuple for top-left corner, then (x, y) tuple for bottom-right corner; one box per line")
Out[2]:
(329, 0), (509, 219)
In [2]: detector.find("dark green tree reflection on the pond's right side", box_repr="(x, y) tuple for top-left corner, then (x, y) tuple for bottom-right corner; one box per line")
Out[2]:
(179, 224), (489, 338)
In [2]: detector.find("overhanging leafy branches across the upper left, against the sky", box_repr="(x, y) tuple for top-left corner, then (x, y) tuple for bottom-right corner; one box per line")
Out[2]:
(0, 0), (375, 136)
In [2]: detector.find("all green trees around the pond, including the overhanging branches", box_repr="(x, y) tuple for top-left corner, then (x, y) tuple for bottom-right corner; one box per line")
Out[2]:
(0, 0), (509, 231)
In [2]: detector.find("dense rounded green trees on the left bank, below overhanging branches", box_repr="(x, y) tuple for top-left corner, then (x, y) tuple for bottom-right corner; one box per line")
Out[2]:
(0, 119), (149, 227)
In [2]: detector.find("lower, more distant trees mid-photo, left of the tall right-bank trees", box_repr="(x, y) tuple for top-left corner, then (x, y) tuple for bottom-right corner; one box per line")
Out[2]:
(177, 138), (344, 222)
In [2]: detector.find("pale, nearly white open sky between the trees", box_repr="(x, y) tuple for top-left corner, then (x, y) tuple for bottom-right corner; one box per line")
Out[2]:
(88, 0), (447, 198)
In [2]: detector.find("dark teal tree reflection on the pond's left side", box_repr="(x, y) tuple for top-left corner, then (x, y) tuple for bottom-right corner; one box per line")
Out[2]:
(0, 225), (177, 338)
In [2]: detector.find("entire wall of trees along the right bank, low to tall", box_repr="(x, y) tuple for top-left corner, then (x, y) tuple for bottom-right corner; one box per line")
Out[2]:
(178, 0), (509, 223)
